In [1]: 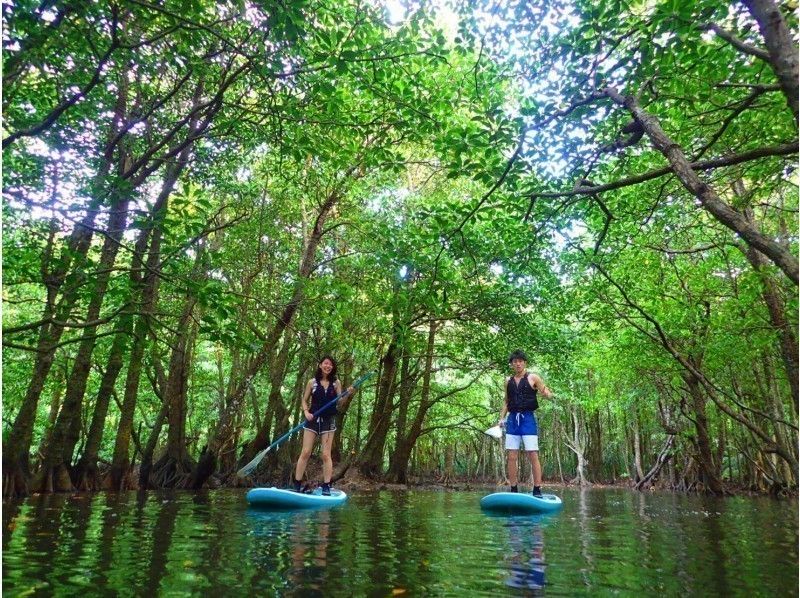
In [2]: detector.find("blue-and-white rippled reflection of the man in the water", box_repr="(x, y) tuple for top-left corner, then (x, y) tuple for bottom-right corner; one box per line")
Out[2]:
(506, 515), (546, 595)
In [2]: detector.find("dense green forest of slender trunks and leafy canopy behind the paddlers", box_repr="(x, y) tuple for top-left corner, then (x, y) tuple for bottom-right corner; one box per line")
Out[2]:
(2, 0), (798, 495)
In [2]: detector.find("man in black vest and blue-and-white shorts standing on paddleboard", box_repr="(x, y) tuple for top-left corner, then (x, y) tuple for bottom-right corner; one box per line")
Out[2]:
(500, 351), (553, 496)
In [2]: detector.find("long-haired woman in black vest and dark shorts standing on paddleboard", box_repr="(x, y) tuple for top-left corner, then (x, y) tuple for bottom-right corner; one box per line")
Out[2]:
(294, 355), (355, 496)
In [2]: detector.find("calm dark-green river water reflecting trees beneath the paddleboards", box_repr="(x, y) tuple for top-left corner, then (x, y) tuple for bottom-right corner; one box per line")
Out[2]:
(2, 489), (798, 596)
